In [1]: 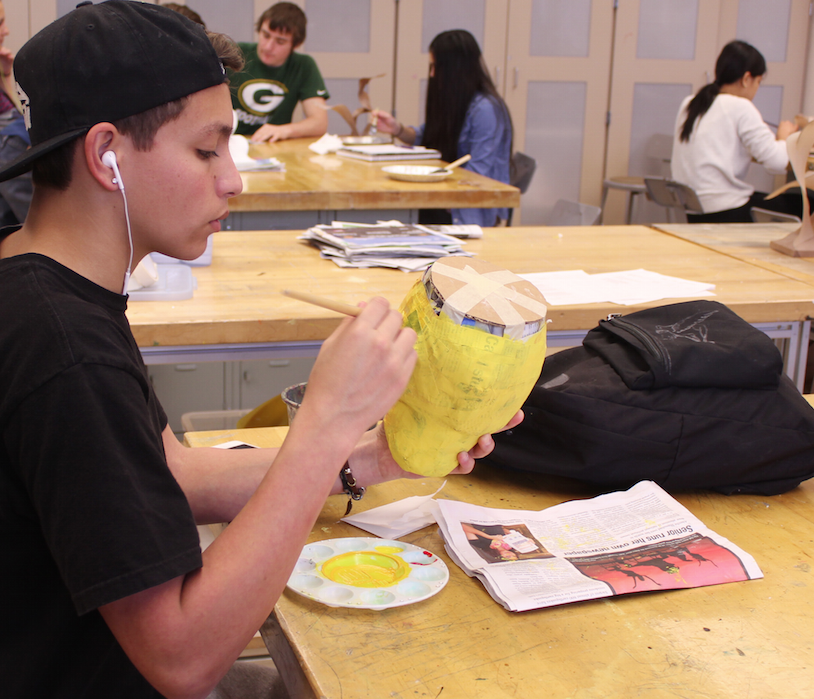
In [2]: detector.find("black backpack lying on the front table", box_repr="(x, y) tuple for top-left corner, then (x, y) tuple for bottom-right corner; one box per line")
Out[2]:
(487, 301), (814, 495)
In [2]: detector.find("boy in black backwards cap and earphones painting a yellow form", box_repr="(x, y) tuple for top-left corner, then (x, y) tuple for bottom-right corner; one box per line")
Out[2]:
(0, 0), (520, 699)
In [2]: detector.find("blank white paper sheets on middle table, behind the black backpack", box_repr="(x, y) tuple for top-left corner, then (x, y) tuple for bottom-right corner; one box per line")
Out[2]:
(520, 269), (715, 306)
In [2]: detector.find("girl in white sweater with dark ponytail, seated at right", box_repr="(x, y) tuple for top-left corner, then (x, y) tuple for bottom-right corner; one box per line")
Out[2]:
(671, 41), (803, 223)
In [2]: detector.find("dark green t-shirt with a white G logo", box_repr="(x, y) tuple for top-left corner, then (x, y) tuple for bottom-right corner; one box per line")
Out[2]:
(230, 43), (330, 136)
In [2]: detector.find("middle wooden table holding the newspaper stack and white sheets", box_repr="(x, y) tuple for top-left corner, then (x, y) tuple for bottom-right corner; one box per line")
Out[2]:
(127, 226), (814, 376)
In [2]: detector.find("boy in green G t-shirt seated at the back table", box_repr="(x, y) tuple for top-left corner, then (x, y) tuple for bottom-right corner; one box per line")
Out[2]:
(231, 2), (330, 143)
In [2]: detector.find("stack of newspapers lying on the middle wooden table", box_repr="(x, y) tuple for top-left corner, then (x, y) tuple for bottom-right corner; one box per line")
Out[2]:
(300, 221), (471, 272)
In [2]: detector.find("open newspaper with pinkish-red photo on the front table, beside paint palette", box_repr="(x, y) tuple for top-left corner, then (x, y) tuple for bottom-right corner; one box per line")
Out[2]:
(437, 481), (763, 612)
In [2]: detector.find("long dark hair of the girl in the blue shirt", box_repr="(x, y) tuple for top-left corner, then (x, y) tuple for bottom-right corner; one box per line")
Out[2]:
(422, 29), (512, 162)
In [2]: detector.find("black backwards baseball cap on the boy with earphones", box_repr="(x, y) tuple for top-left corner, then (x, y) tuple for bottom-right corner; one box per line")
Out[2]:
(0, 0), (226, 182)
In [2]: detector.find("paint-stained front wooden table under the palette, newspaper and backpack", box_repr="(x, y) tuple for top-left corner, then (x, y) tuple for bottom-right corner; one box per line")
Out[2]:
(187, 428), (814, 699)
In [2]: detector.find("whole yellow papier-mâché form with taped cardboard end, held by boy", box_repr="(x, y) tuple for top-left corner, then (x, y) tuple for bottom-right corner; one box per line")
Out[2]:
(384, 257), (546, 476)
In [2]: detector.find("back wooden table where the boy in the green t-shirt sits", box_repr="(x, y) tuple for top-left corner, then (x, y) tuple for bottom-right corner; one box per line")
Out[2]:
(226, 138), (520, 230)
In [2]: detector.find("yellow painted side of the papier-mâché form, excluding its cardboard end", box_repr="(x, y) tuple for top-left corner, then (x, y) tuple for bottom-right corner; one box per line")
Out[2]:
(384, 284), (546, 476)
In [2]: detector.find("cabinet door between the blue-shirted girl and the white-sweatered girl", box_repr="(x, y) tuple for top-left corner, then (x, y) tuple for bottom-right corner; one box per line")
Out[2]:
(505, 0), (613, 225)
